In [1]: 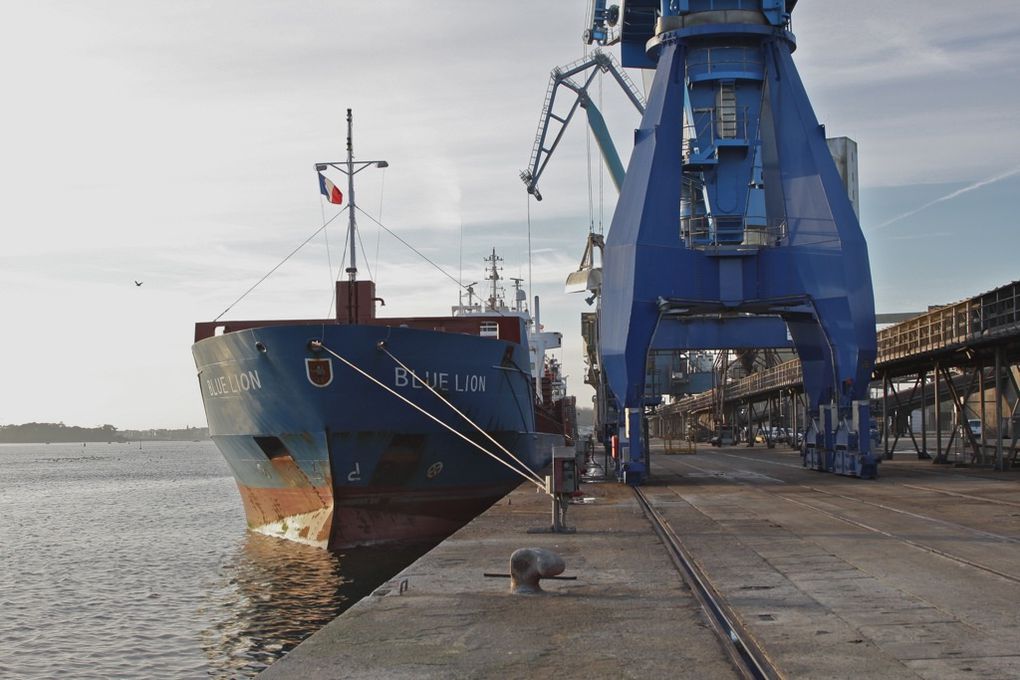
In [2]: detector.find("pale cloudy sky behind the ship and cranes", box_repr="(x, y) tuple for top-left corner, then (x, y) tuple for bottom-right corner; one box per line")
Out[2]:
(0, 0), (1020, 428)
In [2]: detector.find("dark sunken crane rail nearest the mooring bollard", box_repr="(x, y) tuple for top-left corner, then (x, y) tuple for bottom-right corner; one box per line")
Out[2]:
(633, 487), (783, 680)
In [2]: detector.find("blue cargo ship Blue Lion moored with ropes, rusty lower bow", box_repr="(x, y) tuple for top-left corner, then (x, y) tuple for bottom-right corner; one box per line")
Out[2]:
(192, 110), (576, 550)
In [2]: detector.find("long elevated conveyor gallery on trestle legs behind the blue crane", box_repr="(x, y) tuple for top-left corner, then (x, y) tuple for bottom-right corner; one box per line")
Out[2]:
(657, 281), (1020, 464)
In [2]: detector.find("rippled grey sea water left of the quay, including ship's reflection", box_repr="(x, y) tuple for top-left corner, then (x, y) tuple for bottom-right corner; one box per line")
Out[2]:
(0, 441), (427, 678)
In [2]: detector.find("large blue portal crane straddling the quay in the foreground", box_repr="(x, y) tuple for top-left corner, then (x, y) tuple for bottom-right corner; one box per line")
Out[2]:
(589, 0), (877, 483)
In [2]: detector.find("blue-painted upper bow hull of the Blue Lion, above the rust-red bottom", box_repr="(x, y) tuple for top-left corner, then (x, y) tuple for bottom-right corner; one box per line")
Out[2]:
(192, 324), (550, 490)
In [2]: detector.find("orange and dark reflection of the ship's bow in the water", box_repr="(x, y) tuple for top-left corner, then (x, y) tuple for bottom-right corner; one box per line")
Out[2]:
(199, 532), (431, 677)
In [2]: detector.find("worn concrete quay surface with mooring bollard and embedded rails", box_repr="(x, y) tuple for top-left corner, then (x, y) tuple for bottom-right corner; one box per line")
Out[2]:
(263, 447), (1020, 680)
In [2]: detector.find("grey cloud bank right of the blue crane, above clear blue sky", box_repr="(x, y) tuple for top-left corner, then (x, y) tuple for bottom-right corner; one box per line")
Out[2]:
(794, 0), (1020, 187)
